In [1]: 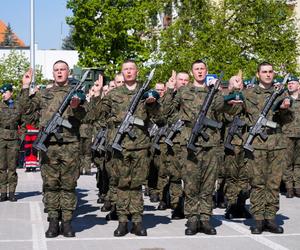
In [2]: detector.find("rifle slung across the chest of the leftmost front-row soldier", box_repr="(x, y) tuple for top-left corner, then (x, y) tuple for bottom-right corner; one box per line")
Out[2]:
(32, 70), (90, 152)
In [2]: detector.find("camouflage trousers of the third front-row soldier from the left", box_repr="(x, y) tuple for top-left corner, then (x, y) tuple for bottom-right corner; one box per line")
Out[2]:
(181, 147), (221, 221)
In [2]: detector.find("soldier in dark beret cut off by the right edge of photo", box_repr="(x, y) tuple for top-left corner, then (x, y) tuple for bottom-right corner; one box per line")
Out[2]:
(282, 76), (300, 198)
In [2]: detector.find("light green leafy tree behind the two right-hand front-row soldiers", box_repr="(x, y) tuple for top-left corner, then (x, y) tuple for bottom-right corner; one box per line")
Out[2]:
(160, 0), (298, 78)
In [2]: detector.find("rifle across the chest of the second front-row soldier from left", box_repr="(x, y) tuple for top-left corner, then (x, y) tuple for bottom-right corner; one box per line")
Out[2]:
(111, 68), (155, 152)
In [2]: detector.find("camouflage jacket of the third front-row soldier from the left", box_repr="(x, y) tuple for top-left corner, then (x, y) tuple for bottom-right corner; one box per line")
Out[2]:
(164, 84), (236, 147)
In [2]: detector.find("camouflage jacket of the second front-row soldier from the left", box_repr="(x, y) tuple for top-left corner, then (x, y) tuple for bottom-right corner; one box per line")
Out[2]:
(96, 86), (158, 150)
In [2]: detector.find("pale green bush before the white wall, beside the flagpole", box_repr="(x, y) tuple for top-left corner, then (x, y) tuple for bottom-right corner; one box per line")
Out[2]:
(0, 50), (42, 89)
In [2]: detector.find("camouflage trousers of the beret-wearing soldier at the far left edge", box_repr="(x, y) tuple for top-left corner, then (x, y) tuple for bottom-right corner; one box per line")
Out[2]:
(0, 139), (19, 193)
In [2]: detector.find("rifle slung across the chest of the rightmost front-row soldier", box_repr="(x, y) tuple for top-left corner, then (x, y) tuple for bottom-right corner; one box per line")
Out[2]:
(243, 74), (290, 152)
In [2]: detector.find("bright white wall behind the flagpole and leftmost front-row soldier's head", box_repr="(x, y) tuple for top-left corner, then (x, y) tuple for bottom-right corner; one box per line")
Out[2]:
(0, 49), (78, 79)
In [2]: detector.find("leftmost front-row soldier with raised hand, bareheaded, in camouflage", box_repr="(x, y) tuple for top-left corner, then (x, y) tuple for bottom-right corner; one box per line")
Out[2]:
(20, 60), (85, 238)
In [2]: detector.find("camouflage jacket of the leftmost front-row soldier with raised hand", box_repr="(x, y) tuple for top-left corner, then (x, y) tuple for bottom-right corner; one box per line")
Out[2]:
(20, 85), (85, 142)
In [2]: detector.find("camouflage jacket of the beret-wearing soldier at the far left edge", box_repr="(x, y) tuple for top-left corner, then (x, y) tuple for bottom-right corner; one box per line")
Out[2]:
(0, 98), (21, 140)
